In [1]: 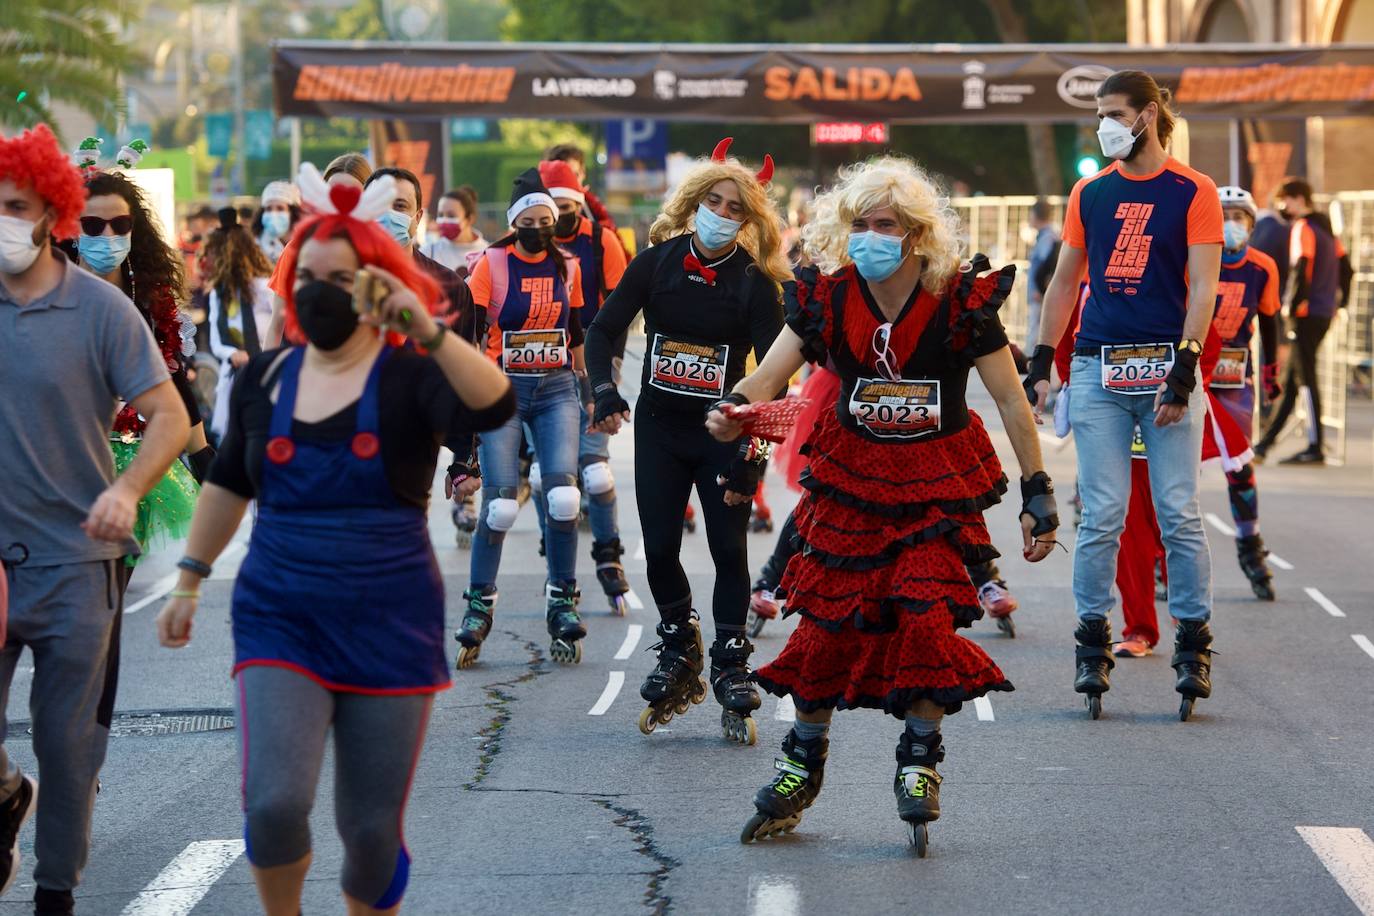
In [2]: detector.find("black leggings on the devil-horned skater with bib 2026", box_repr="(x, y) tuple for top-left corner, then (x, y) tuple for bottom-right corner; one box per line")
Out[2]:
(635, 402), (749, 634)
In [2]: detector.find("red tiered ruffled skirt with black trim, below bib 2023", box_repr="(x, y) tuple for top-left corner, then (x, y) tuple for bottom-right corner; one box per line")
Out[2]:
(756, 411), (1011, 717)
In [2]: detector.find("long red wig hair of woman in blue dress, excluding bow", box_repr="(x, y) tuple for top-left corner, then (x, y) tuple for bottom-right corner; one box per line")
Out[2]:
(278, 213), (447, 346)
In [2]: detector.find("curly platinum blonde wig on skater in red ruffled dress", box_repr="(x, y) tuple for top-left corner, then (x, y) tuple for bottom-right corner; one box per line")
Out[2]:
(801, 157), (963, 295)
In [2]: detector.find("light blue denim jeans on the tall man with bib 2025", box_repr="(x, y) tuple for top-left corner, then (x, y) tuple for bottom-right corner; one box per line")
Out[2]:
(1069, 356), (1212, 619)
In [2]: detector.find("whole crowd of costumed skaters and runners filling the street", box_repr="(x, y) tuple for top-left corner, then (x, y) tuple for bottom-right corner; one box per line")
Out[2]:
(0, 71), (1349, 915)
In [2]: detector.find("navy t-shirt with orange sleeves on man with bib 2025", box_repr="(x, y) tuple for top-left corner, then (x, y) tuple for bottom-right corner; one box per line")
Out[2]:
(1063, 157), (1221, 346)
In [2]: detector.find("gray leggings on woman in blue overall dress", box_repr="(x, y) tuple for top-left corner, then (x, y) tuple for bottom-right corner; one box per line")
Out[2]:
(238, 665), (433, 909)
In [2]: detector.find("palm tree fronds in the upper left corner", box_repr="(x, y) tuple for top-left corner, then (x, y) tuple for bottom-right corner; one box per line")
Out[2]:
(0, 0), (137, 135)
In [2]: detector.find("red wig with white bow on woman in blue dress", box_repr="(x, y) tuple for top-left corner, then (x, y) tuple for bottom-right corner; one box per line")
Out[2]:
(278, 162), (447, 346)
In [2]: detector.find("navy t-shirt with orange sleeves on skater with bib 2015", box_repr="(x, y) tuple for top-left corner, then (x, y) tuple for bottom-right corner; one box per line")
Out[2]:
(467, 251), (583, 364)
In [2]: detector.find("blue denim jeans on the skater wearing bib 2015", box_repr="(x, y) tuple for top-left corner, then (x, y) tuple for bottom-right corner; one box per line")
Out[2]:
(471, 369), (583, 588)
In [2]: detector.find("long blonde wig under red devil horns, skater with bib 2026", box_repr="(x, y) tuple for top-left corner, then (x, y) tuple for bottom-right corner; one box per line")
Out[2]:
(649, 159), (791, 283)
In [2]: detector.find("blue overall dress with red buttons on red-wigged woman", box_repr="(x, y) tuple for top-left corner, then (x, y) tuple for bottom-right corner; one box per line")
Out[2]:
(232, 347), (449, 694)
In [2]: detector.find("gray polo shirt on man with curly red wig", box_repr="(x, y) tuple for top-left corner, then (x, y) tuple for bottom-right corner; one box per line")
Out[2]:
(0, 253), (170, 566)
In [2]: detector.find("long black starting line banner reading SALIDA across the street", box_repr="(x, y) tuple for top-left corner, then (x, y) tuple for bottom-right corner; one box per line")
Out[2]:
(272, 41), (1374, 124)
